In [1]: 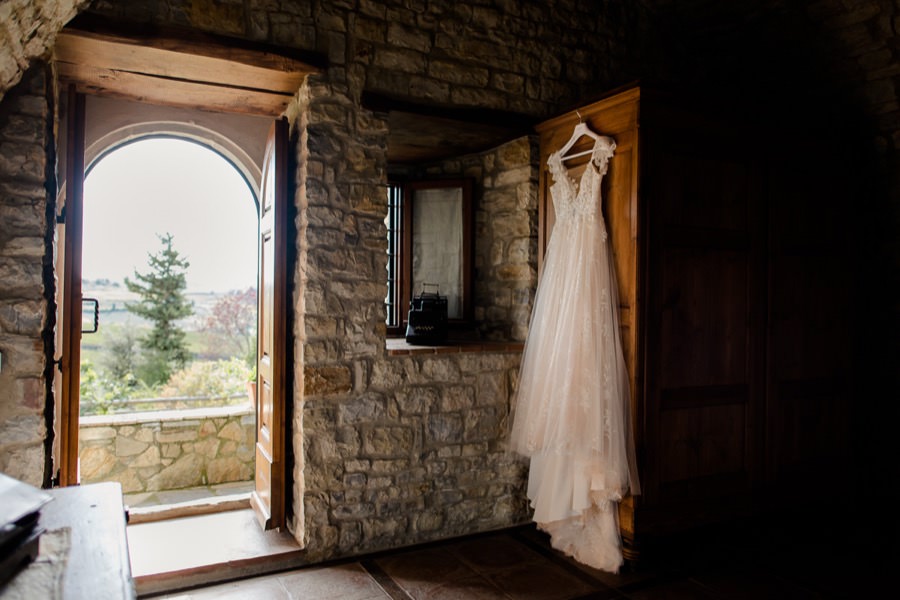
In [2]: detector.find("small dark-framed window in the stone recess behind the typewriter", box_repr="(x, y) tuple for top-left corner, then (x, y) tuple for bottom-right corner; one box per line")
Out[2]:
(385, 179), (474, 335)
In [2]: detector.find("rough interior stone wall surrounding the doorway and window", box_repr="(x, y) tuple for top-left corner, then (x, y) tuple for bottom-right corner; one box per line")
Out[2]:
(0, 0), (900, 558)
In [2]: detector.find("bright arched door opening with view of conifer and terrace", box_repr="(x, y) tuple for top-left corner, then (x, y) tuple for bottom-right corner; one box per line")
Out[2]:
(79, 134), (258, 509)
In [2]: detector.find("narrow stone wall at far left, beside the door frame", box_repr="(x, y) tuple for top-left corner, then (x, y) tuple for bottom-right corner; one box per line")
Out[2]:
(0, 66), (55, 485)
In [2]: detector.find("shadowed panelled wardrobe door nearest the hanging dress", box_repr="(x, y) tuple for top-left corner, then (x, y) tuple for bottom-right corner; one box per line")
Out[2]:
(642, 129), (765, 526)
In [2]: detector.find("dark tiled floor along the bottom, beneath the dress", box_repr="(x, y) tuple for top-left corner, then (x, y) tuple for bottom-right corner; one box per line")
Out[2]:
(144, 523), (898, 600)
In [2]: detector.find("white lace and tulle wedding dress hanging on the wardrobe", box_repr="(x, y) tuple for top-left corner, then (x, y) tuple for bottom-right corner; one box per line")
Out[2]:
(510, 137), (640, 572)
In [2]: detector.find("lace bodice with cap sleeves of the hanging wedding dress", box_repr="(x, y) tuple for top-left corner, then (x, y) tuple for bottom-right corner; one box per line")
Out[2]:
(547, 136), (616, 221)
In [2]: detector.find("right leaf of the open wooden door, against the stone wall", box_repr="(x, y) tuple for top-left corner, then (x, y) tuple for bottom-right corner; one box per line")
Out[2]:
(251, 119), (290, 529)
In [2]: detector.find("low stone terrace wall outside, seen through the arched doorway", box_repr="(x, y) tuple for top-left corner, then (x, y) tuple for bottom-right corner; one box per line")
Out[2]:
(78, 404), (256, 494)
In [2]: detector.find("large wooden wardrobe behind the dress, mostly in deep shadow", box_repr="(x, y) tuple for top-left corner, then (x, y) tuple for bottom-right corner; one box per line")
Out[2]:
(537, 87), (852, 560)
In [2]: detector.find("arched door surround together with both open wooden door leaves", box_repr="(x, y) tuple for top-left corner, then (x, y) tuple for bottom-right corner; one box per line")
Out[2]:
(54, 88), (289, 528)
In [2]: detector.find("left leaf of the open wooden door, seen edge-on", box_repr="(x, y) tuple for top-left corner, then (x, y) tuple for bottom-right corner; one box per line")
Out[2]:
(56, 86), (85, 485)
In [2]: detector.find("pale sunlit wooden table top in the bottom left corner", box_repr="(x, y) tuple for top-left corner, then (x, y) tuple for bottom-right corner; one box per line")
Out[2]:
(40, 482), (136, 600)
